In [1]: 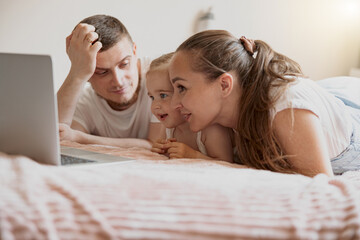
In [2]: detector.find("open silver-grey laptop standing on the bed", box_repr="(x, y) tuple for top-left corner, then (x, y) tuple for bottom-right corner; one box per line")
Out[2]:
(0, 53), (134, 165)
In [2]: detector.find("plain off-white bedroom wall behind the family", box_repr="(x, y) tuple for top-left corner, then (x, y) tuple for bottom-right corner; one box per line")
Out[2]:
(0, 0), (360, 89)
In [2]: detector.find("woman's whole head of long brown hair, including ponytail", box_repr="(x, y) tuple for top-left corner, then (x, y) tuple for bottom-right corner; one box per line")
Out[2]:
(177, 30), (303, 173)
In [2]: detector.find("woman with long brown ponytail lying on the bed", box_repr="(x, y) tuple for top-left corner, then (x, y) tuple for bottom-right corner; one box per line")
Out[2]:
(169, 30), (360, 176)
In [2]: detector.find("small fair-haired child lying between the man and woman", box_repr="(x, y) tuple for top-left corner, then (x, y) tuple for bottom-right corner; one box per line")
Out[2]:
(146, 53), (233, 162)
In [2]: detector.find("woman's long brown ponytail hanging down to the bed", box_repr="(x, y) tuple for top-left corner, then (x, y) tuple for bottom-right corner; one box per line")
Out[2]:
(236, 40), (302, 173)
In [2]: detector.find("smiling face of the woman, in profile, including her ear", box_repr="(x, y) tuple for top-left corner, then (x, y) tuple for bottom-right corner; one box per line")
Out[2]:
(169, 51), (222, 132)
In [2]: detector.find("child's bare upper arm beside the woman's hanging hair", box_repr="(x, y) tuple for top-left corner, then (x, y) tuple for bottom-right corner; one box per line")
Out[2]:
(202, 124), (234, 163)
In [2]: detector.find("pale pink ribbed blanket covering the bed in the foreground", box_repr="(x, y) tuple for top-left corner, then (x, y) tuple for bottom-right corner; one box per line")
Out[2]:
(0, 142), (360, 239)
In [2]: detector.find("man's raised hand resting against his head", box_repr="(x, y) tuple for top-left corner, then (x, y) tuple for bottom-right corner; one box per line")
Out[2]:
(66, 23), (102, 81)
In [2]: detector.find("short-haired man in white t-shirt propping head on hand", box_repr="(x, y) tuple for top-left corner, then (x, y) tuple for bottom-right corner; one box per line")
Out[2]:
(57, 15), (162, 147)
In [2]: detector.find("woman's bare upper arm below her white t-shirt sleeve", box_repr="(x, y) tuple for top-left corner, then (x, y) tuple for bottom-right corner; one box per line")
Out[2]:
(273, 109), (333, 176)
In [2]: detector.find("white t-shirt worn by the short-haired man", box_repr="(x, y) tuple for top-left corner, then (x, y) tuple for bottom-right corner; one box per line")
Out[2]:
(73, 57), (152, 139)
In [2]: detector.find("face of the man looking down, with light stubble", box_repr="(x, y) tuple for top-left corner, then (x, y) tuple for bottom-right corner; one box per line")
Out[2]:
(89, 38), (139, 110)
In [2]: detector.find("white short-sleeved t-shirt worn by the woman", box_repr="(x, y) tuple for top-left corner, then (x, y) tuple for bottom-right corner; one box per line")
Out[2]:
(270, 78), (352, 158)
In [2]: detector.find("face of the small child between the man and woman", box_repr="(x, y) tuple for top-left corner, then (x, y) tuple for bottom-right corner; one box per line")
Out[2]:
(146, 67), (185, 128)
